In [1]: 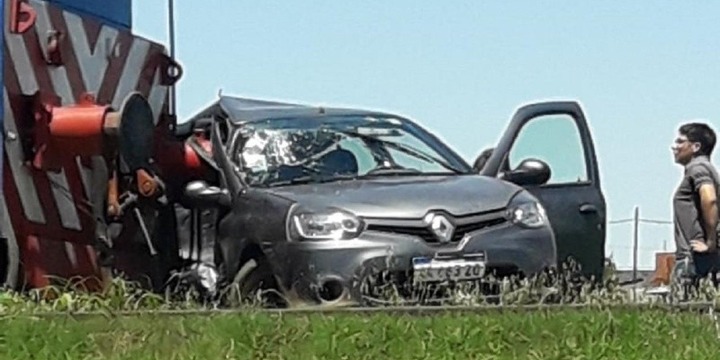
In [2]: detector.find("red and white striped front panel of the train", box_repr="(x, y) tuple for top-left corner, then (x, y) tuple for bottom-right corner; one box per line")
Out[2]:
(0, 0), (168, 286)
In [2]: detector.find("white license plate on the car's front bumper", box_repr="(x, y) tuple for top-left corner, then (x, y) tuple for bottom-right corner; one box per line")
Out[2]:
(413, 258), (485, 283)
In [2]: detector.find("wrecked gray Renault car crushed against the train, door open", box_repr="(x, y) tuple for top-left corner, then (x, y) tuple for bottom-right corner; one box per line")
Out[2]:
(177, 96), (605, 306)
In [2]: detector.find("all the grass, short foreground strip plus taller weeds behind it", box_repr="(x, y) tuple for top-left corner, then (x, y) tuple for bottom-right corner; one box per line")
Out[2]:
(0, 258), (720, 359)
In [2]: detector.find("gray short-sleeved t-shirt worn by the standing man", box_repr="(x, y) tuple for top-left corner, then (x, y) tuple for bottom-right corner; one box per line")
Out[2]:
(673, 156), (720, 259)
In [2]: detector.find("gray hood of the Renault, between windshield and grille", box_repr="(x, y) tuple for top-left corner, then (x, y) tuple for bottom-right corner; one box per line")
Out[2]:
(268, 175), (521, 219)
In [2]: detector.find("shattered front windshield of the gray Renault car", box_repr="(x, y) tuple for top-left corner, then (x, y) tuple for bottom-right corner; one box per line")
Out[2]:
(230, 115), (464, 186)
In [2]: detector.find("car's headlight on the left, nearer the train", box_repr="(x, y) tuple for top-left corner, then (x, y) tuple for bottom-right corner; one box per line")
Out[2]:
(290, 209), (364, 240)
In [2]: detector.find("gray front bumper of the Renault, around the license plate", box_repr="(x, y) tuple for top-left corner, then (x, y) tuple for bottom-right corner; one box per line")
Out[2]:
(267, 219), (557, 305)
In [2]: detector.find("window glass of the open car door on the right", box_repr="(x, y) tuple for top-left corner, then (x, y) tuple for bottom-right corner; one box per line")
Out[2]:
(507, 114), (588, 184)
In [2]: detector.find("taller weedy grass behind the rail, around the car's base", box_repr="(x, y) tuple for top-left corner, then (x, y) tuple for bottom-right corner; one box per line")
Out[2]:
(0, 262), (720, 314)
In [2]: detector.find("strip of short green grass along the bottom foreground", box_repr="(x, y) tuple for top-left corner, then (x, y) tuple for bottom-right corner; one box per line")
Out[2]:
(0, 309), (720, 360)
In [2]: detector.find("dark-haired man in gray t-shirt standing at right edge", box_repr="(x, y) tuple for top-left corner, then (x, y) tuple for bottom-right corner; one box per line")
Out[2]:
(672, 122), (720, 296)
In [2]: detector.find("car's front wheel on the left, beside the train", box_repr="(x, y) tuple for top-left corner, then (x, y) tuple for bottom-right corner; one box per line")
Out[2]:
(228, 257), (287, 308)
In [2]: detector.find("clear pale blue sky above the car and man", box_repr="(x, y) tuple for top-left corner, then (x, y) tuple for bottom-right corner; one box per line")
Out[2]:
(133, 0), (720, 268)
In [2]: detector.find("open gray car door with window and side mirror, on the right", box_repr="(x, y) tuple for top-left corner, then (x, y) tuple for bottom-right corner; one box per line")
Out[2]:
(480, 101), (606, 279)
